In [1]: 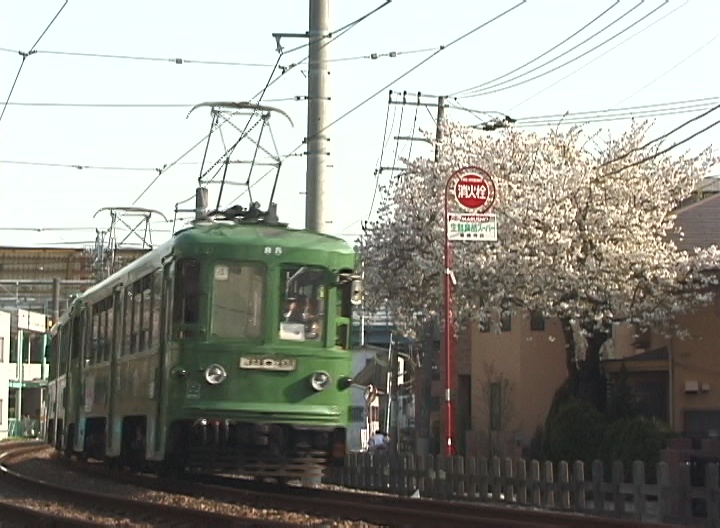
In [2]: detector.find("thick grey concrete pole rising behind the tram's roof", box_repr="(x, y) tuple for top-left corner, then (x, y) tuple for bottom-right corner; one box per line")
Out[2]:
(305, 0), (333, 233)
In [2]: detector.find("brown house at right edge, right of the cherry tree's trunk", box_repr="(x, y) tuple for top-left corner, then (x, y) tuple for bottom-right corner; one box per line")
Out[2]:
(604, 193), (720, 440)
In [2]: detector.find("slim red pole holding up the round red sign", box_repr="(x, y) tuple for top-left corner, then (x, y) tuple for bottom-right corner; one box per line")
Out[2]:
(443, 174), (455, 456)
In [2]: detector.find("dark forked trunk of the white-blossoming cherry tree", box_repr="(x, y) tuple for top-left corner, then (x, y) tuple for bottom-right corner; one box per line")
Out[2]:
(562, 320), (610, 412)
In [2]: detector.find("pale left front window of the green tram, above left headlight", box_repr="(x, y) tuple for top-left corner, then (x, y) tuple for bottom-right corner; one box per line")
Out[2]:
(212, 264), (265, 338)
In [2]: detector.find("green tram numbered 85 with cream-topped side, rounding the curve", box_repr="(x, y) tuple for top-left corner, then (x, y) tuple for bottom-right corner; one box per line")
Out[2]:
(46, 211), (361, 480)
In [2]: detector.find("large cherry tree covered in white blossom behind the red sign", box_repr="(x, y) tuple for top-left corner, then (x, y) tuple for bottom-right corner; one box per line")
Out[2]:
(364, 122), (720, 406)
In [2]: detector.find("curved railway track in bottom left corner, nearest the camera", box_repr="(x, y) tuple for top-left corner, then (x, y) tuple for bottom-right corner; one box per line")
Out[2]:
(0, 442), (297, 528)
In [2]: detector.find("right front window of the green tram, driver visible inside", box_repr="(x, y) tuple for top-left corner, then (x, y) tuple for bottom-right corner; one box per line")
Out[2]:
(279, 266), (329, 342)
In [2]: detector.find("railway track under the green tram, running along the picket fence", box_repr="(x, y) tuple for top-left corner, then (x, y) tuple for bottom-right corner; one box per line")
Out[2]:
(38, 444), (669, 528)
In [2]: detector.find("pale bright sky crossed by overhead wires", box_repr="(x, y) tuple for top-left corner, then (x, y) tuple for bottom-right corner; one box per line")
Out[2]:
(0, 0), (720, 250)
